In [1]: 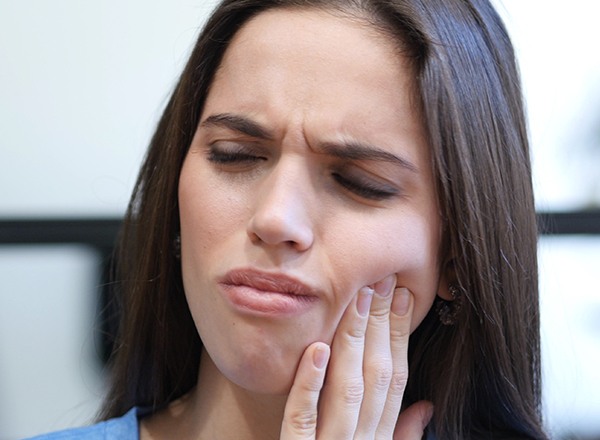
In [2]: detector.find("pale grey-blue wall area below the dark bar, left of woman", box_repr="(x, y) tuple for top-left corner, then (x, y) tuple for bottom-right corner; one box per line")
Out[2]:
(0, 246), (103, 439)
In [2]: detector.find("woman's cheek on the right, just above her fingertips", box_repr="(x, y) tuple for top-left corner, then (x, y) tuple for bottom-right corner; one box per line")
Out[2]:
(330, 210), (441, 330)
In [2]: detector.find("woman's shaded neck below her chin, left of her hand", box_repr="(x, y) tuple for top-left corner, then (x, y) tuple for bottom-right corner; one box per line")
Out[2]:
(143, 351), (287, 440)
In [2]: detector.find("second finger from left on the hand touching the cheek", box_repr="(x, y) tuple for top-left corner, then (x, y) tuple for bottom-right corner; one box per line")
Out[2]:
(319, 287), (373, 439)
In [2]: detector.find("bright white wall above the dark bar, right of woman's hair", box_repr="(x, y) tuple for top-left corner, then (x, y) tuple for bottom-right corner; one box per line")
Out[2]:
(494, 0), (600, 209)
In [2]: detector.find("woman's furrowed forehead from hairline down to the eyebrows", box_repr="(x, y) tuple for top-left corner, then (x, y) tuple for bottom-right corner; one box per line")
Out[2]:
(203, 8), (422, 162)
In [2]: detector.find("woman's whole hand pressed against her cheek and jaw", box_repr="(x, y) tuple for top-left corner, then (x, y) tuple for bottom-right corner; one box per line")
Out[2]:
(281, 276), (432, 440)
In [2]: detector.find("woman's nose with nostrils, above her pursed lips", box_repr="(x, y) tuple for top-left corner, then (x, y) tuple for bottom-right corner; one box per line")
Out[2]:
(247, 163), (314, 251)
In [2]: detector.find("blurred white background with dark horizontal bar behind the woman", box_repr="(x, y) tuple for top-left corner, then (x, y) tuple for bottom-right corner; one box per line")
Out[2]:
(0, 0), (600, 440)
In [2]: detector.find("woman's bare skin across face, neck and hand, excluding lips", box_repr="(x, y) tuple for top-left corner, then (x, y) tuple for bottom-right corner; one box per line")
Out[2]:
(141, 6), (445, 439)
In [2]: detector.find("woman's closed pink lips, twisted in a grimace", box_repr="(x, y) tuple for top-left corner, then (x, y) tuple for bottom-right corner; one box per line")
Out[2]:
(218, 269), (319, 315)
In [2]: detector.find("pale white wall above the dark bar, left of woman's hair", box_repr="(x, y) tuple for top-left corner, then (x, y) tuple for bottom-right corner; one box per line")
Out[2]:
(0, 0), (220, 216)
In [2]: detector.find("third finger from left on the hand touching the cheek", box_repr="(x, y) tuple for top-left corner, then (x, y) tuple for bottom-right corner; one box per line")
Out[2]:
(356, 275), (396, 439)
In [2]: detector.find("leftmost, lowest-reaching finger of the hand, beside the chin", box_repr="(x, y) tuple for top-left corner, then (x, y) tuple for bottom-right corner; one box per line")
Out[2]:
(280, 342), (330, 440)
